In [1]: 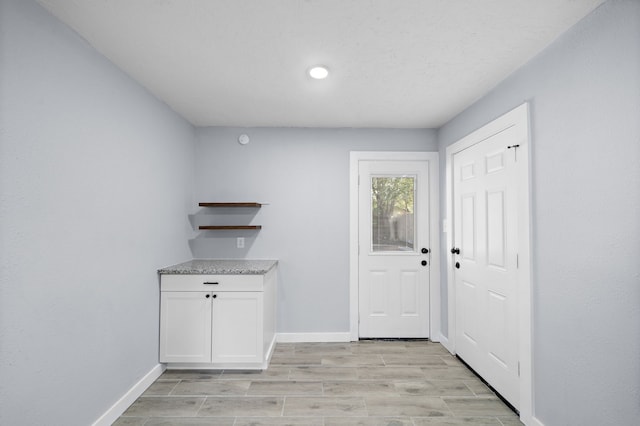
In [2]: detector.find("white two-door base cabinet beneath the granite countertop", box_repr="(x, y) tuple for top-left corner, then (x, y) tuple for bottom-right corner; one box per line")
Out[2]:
(160, 268), (276, 369)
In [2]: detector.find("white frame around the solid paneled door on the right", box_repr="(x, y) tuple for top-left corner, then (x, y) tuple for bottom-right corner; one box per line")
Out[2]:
(443, 102), (534, 424)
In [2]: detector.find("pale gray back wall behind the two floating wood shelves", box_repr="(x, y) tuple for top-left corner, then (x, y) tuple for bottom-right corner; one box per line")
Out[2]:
(191, 128), (437, 333)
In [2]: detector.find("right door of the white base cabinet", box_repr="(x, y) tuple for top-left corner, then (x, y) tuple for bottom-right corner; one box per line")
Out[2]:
(212, 292), (263, 363)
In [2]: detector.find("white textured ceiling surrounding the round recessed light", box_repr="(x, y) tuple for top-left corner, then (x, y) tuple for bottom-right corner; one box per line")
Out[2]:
(40, 0), (604, 128)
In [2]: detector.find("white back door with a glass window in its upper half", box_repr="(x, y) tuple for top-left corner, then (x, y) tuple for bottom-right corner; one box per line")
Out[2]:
(358, 160), (431, 338)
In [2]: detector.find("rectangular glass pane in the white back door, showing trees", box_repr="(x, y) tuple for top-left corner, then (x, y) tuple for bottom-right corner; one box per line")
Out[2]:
(371, 176), (416, 252)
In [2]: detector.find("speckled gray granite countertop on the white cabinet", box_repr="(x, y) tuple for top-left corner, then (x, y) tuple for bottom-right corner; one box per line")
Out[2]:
(158, 259), (278, 275)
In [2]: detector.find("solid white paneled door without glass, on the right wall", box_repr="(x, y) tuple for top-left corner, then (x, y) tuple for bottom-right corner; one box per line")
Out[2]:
(452, 127), (520, 408)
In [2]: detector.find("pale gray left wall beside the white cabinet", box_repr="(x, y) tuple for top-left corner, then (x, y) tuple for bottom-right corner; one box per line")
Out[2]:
(0, 0), (194, 425)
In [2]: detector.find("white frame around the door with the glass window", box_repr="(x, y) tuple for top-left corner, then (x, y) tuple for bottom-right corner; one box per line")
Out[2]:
(349, 151), (441, 342)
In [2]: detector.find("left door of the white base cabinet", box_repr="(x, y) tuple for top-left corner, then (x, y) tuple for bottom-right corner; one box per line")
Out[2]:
(160, 291), (211, 362)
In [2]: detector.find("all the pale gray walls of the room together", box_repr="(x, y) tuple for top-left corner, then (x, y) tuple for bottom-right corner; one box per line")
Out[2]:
(0, 0), (640, 426)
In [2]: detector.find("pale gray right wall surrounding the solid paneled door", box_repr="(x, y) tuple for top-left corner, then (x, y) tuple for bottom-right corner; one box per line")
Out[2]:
(438, 0), (640, 426)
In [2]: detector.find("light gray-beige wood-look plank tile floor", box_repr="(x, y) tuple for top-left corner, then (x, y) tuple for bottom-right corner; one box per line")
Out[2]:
(114, 340), (521, 426)
